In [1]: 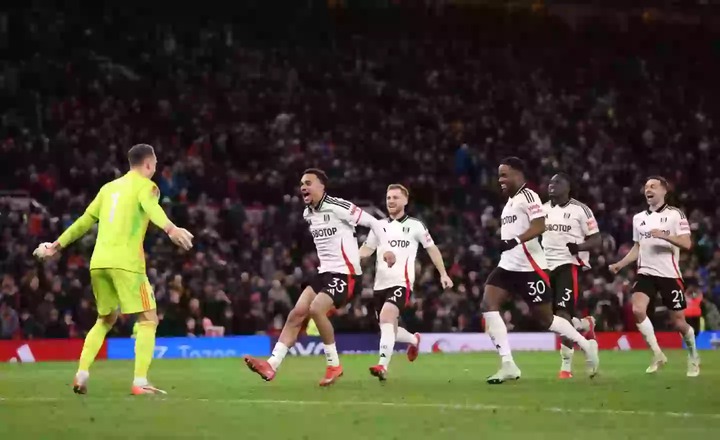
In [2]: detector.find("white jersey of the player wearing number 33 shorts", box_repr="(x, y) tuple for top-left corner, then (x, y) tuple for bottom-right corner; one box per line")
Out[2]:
(303, 194), (363, 275)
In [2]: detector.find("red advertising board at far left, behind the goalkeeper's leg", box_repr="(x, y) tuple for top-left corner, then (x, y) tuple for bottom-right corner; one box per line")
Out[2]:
(0, 339), (107, 362)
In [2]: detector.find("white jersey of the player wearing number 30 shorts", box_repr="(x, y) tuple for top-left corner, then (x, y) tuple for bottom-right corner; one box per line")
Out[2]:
(498, 185), (547, 272)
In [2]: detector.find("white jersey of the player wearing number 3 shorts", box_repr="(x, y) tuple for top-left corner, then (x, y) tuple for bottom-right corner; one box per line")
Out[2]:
(542, 199), (600, 270)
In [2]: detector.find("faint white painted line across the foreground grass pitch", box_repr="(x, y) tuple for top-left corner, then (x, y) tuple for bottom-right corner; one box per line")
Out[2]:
(0, 397), (720, 420)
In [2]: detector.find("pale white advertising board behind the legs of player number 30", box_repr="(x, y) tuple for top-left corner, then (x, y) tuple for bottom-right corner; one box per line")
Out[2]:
(420, 333), (556, 353)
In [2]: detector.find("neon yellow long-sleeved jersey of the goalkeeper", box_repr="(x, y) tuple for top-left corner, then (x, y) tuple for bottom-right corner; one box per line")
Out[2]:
(58, 171), (170, 273)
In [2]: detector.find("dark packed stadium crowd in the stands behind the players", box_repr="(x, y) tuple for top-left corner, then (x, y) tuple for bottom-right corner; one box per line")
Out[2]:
(0, 5), (720, 338)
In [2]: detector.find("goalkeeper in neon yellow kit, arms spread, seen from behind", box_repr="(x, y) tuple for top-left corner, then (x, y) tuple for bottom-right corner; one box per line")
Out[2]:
(35, 144), (193, 395)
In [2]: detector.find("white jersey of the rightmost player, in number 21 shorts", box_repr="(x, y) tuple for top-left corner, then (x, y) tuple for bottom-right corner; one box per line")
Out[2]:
(633, 204), (690, 279)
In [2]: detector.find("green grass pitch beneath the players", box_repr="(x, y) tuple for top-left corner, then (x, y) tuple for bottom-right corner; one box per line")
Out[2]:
(0, 351), (720, 440)
